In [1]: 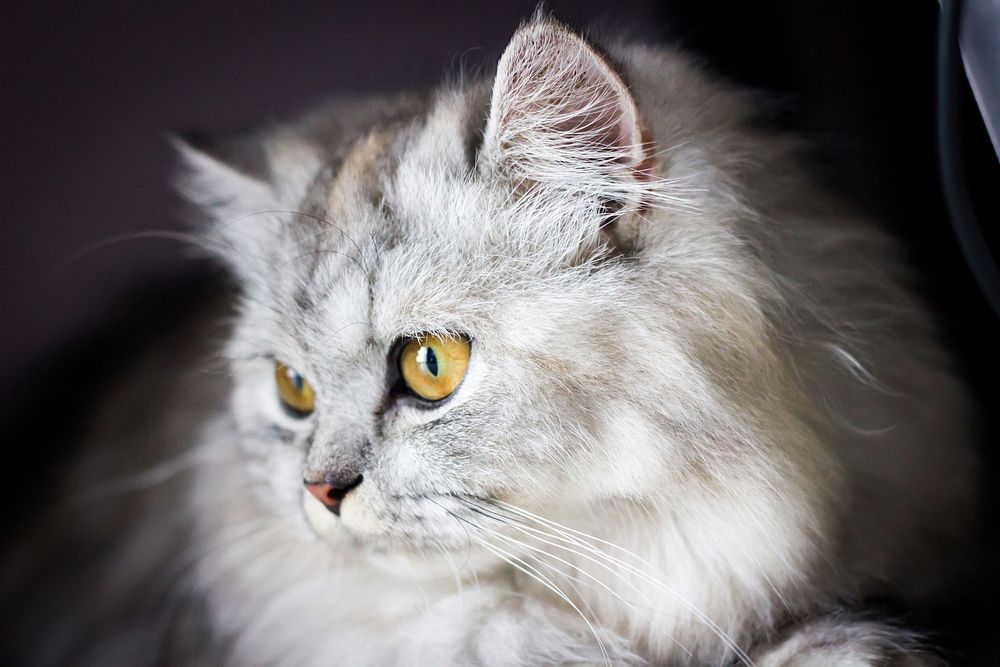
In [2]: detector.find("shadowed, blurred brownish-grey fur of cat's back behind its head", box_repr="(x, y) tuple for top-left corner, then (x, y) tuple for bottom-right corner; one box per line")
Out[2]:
(615, 39), (980, 597)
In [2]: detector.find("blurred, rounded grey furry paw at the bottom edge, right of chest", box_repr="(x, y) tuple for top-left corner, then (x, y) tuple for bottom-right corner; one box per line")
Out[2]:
(754, 615), (946, 667)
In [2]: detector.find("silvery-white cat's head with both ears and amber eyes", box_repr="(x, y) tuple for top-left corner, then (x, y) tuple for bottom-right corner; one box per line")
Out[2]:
(182, 19), (828, 564)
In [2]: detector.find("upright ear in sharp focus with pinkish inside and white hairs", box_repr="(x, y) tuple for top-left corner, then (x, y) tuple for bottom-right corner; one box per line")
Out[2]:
(480, 18), (654, 213)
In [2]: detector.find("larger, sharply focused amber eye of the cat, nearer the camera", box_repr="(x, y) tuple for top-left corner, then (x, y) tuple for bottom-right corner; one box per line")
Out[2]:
(399, 336), (472, 401)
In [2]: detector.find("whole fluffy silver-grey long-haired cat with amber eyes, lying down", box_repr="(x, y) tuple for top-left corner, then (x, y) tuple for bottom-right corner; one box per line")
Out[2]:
(2, 14), (978, 667)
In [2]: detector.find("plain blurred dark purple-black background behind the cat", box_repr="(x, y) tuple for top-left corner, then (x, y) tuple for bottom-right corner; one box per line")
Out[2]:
(0, 0), (1000, 664)
